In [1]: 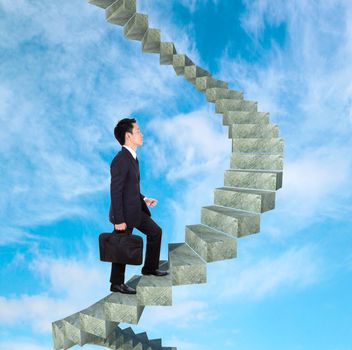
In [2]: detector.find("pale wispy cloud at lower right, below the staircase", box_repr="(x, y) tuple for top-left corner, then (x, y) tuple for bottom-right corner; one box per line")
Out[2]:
(208, 246), (323, 302)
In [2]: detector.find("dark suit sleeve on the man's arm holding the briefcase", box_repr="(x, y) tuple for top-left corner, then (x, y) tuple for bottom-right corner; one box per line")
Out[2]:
(110, 158), (128, 224)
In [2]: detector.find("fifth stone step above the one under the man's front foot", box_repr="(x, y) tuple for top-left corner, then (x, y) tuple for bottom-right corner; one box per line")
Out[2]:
(224, 169), (282, 191)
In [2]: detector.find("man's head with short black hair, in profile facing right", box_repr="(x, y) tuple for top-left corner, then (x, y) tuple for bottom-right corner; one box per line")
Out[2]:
(114, 118), (143, 149)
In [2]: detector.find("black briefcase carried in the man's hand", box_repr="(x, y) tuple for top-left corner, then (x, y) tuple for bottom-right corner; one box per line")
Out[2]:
(99, 231), (143, 265)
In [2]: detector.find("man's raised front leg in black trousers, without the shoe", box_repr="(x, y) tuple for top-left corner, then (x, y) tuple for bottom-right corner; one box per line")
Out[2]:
(136, 211), (162, 271)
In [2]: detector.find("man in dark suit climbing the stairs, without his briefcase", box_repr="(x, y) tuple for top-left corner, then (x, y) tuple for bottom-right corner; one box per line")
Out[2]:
(109, 118), (167, 294)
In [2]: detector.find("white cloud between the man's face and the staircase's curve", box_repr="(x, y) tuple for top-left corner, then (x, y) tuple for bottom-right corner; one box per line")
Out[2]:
(145, 109), (231, 183)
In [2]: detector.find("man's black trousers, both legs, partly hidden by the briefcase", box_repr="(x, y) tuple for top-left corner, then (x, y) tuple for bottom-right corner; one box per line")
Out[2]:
(110, 211), (162, 284)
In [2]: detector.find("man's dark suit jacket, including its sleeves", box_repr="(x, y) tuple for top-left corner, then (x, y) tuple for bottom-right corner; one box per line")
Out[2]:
(109, 147), (151, 227)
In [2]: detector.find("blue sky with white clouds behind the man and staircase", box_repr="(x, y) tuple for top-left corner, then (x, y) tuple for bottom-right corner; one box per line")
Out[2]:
(0, 0), (352, 350)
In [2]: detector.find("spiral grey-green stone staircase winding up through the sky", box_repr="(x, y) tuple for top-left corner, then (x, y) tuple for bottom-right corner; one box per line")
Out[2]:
(52, 0), (284, 350)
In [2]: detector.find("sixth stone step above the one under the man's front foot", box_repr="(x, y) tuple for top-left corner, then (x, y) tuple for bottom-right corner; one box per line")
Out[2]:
(230, 153), (284, 170)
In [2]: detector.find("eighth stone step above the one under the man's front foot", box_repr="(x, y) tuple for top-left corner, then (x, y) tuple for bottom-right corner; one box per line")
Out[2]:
(229, 124), (279, 138)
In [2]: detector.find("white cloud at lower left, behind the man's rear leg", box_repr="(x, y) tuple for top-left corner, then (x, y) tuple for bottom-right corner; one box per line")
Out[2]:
(0, 252), (109, 333)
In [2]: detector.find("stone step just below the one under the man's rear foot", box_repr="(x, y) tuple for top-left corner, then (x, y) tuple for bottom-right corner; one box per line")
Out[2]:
(79, 299), (118, 338)
